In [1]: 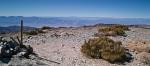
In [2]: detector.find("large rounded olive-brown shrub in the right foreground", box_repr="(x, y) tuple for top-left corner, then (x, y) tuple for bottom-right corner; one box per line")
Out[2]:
(81, 37), (125, 62)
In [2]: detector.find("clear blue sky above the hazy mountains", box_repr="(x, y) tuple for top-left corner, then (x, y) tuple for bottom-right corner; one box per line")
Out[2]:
(0, 0), (150, 18)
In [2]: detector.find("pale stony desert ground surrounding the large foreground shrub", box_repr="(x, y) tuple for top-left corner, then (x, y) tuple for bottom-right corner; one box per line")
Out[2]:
(0, 27), (150, 66)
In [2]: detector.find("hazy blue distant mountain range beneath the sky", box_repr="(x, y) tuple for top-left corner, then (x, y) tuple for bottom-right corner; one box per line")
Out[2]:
(0, 16), (150, 27)
